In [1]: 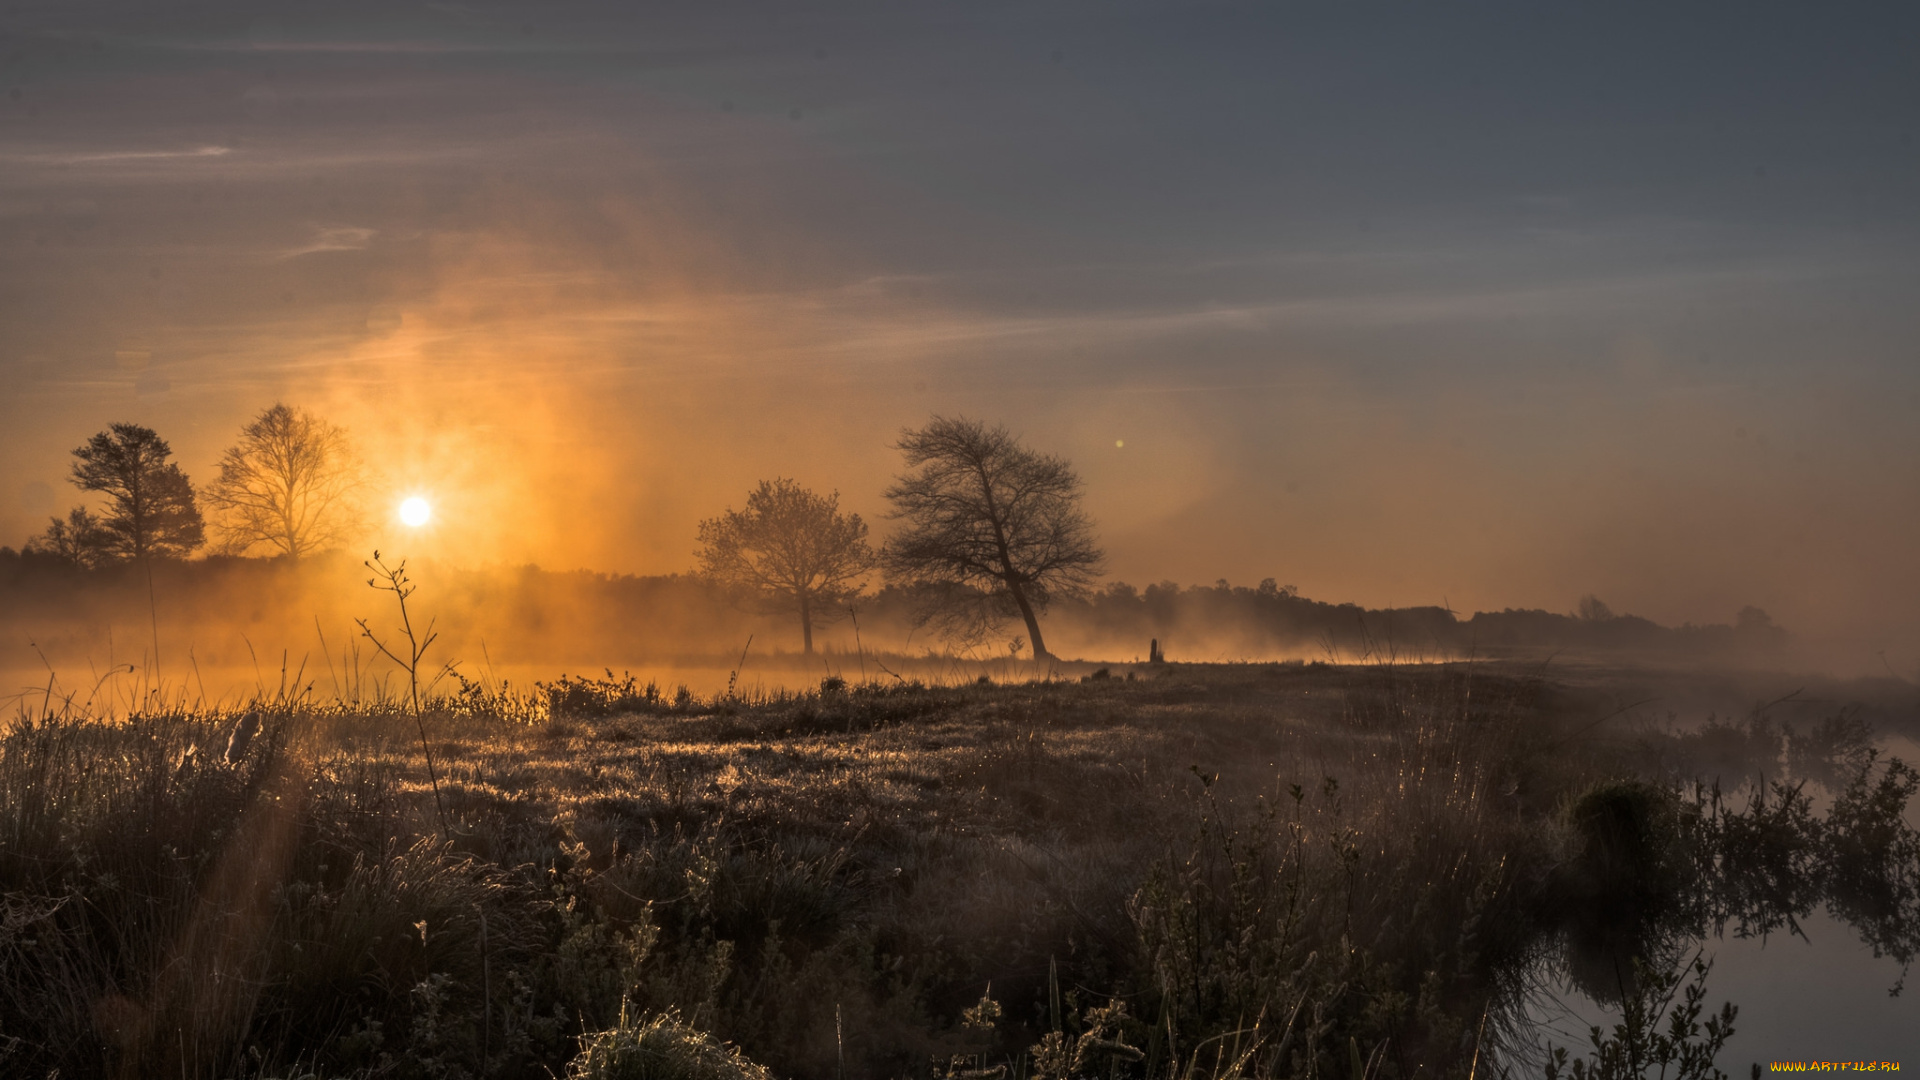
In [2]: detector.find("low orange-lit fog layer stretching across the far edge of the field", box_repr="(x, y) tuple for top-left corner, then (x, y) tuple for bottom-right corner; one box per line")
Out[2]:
(0, 552), (1827, 701)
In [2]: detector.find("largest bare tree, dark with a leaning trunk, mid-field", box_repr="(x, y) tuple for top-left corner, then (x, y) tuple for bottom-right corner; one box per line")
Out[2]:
(881, 417), (1104, 659)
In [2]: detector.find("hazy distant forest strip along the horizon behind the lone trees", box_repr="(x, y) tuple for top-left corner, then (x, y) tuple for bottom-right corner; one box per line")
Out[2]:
(0, 548), (1789, 669)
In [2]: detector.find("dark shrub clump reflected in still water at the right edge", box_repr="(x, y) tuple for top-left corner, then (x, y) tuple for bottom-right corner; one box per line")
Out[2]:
(1546, 726), (1920, 1060)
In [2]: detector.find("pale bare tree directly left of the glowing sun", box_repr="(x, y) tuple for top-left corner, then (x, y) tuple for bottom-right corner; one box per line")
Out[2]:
(205, 404), (365, 559)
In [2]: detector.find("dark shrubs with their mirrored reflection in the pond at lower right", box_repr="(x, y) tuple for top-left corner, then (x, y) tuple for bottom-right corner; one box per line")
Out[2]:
(1519, 713), (1920, 1065)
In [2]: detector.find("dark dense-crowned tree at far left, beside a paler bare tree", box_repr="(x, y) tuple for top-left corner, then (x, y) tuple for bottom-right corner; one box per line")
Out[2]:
(71, 425), (205, 559)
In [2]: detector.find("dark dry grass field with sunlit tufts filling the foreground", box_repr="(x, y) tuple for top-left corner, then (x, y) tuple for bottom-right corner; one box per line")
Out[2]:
(0, 665), (1920, 1080)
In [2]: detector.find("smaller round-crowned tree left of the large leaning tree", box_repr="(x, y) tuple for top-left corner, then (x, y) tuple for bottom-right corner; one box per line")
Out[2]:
(697, 479), (874, 655)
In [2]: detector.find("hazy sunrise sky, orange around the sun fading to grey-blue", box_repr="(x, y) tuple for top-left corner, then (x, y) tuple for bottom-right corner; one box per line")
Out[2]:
(0, 0), (1920, 665)
